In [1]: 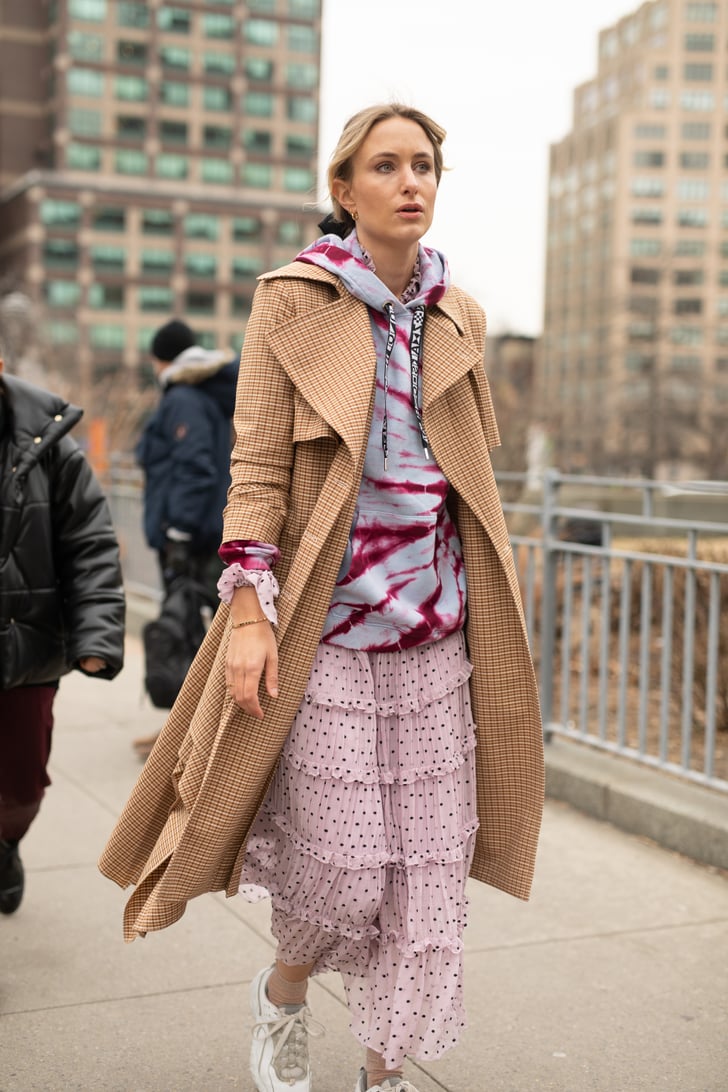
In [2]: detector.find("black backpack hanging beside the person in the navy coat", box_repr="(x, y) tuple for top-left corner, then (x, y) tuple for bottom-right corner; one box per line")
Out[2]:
(142, 575), (207, 709)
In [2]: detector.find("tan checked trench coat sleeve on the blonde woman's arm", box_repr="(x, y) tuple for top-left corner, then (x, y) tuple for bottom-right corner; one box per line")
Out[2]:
(223, 273), (295, 545)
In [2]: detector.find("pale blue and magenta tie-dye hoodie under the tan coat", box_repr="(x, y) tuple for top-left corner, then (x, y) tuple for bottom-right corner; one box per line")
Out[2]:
(298, 233), (465, 651)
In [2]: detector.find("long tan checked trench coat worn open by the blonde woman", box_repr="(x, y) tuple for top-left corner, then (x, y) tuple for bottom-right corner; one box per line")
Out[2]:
(99, 262), (544, 940)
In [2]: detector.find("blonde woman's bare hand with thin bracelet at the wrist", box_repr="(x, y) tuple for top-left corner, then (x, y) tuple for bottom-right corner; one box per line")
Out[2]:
(225, 587), (278, 720)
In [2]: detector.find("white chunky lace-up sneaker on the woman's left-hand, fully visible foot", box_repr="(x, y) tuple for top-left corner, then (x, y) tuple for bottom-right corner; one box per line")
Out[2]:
(250, 966), (323, 1092)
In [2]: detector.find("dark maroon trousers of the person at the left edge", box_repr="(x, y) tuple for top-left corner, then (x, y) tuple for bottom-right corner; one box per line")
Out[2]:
(0, 685), (58, 842)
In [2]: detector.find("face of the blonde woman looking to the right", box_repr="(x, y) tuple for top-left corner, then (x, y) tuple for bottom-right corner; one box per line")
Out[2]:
(334, 117), (438, 250)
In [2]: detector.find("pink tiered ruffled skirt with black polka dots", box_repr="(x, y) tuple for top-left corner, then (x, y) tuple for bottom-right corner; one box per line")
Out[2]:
(240, 632), (478, 1068)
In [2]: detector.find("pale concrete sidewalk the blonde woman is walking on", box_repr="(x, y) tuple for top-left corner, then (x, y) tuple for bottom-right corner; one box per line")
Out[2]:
(0, 638), (728, 1092)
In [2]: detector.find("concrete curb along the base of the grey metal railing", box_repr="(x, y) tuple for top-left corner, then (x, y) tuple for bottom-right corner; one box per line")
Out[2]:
(127, 592), (728, 870)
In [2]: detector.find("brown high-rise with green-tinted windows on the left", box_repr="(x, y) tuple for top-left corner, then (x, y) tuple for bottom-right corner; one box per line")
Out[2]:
(0, 0), (321, 454)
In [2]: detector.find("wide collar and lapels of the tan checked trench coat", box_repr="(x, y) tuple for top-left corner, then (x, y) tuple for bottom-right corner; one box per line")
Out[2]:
(260, 262), (482, 464)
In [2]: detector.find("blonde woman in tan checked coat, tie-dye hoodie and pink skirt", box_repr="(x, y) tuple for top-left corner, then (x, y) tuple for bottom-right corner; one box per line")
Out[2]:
(102, 105), (542, 1092)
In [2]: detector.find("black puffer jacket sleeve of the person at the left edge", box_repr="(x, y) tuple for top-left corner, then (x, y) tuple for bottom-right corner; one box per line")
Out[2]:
(50, 438), (126, 678)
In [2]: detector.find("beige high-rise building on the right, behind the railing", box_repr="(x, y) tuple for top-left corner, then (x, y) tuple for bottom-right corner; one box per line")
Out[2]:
(538, 0), (728, 477)
